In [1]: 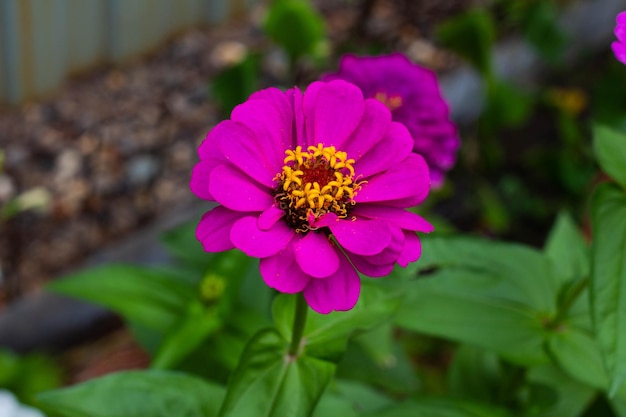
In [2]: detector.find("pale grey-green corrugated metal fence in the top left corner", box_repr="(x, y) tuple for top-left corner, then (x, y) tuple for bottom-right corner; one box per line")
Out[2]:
(0, 0), (244, 104)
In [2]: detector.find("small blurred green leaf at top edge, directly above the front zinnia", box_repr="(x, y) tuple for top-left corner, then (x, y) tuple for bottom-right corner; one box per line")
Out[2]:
(265, 0), (324, 63)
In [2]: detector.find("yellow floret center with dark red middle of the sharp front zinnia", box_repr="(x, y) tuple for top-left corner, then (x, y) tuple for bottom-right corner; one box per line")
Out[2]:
(275, 143), (359, 233)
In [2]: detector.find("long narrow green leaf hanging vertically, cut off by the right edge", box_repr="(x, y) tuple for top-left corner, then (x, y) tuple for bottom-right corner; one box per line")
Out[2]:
(591, 184), (626, 394)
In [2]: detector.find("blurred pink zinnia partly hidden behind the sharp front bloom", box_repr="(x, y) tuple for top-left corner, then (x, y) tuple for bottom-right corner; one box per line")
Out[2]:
(322, 53), (460, 187)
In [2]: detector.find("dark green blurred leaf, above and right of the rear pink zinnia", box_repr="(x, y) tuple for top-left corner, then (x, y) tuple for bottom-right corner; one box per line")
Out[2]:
(436, 8), (495, 78)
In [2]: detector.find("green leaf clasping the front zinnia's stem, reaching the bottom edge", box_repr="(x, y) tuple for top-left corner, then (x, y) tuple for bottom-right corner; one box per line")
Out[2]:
(219, 329), (335, 417)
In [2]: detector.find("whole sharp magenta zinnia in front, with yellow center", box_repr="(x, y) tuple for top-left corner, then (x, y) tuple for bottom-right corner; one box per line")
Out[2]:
(191, 81), (433, 313)
